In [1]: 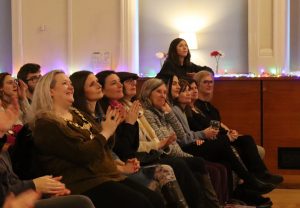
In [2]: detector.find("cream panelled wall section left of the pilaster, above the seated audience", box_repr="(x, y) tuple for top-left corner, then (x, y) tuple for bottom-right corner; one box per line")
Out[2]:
(12, 0), (120, 73)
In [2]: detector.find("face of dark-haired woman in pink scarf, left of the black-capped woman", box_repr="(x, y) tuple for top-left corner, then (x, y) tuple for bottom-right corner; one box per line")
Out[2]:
(102, 74), (124, 100)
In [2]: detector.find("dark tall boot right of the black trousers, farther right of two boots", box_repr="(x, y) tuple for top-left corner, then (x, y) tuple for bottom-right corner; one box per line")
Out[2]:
(200, 174), (221, 208)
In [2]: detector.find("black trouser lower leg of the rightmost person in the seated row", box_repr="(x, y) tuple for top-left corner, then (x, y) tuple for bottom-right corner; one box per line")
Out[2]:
(231, 135), (267, 174)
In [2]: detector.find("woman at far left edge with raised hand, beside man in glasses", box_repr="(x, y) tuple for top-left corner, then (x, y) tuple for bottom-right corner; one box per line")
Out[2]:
(0, 72), (30, 146)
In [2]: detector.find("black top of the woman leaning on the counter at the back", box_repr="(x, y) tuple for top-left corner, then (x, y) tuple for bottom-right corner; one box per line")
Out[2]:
(157, 59), (214, 78)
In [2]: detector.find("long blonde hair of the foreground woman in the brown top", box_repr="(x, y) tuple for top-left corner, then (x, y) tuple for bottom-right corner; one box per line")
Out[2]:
(28, 70), (64, 127)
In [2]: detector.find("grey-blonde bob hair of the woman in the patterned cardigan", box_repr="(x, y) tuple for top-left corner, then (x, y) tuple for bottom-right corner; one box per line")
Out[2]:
(139, 78), (165, 108)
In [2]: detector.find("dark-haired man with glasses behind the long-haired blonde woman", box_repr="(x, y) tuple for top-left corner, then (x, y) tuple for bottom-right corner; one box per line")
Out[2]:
(17, 63), (42, 103)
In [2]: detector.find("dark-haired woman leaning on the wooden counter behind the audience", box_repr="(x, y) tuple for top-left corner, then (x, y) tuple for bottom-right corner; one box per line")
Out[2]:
(157, 38), (213, 78)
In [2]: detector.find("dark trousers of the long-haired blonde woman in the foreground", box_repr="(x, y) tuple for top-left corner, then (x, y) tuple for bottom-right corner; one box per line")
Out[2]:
(83, 178), (164, 208)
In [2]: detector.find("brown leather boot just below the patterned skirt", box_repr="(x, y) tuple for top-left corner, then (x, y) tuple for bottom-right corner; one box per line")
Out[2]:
(161, 181), (188, 208)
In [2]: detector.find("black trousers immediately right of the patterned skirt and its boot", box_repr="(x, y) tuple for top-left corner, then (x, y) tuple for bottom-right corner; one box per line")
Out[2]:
(160, 156), (206, 208)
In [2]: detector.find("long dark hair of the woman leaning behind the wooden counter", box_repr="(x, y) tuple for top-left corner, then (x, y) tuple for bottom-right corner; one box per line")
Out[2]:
(167, 38), (191, 66)
